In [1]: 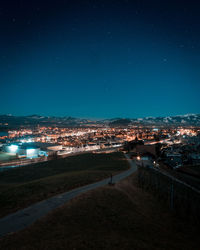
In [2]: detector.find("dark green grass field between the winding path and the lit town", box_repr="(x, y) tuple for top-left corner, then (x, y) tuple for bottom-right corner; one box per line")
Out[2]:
(0, 153), (128, 217)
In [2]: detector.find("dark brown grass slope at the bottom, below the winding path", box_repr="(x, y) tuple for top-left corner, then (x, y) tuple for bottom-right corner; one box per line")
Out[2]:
(0, 176), (199, 250)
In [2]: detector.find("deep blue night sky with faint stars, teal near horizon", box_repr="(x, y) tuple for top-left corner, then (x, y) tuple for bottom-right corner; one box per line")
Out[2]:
(0, 0), (200, 118)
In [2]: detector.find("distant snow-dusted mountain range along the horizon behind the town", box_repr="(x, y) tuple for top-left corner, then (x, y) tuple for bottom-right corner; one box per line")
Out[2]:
(0, 114), (200, 128)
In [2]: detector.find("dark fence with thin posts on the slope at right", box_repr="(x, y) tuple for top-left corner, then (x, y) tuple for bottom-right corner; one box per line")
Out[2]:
(138, 166), (200, 224)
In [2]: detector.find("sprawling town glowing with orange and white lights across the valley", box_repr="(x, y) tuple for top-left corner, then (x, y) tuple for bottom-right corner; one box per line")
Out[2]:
(0, 125), (200, 176)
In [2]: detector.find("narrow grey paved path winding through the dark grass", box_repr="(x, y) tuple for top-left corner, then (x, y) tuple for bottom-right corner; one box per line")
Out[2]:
(0, 155), (137, 237)
